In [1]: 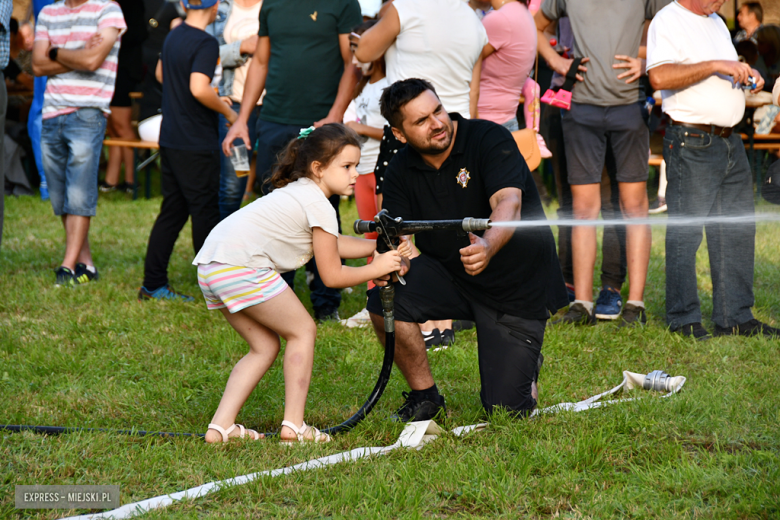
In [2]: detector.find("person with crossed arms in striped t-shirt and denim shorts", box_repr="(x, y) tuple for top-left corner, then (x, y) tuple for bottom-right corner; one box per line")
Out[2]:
(32, 0), (127, 286)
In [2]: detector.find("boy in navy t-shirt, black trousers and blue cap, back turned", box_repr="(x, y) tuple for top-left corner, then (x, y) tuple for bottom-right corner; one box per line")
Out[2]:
(138, 0), (238, 301)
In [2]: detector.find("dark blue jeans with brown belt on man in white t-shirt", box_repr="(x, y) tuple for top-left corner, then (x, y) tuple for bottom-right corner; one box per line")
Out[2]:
(664, 126), (756, 330)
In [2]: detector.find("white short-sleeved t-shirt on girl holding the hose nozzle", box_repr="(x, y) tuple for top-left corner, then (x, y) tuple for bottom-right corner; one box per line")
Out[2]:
(192, 178), (339, 273)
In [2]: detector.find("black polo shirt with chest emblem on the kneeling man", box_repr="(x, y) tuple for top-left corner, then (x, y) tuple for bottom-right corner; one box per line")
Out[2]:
(383, 114), (568, 319)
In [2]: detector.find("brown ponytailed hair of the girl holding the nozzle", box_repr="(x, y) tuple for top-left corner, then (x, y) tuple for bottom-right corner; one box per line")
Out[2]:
(266, 123), (360, 188)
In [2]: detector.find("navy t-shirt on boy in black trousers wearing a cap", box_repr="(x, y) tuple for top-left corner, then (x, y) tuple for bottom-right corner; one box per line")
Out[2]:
(160, 23), (219, 151)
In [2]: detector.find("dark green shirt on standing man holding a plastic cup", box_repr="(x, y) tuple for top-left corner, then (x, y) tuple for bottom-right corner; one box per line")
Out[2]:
(258, 0), (363, 126)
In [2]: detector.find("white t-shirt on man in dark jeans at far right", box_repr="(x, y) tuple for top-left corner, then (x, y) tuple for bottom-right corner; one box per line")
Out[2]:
(647, 2), (745, 127)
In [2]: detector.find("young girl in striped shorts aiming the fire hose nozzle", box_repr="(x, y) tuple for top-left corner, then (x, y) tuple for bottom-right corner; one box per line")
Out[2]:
(193, 123), (410, 442)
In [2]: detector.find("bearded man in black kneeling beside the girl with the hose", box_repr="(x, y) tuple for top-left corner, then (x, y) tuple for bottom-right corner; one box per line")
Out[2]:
(368, 79), (568, 421)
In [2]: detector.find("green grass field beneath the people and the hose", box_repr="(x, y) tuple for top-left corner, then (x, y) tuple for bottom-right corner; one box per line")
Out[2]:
(0, 188), (780, 519)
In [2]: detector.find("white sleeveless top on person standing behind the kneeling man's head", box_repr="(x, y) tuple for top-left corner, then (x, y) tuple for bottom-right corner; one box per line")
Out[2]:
(385, 0), (488, 117)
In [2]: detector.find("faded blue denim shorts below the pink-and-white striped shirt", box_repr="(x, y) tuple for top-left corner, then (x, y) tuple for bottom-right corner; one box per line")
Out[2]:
(41, 108), (106, 217)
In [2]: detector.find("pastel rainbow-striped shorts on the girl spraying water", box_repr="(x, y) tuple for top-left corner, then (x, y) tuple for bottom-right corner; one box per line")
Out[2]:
(198, 262), (287, 314)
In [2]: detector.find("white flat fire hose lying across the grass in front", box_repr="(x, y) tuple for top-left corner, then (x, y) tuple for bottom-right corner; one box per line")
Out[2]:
(63, 371), (685, 520)
